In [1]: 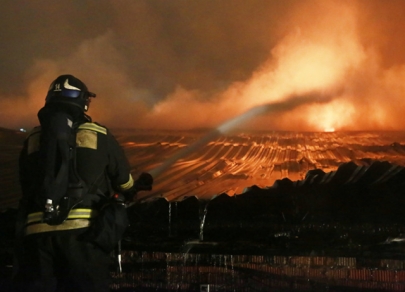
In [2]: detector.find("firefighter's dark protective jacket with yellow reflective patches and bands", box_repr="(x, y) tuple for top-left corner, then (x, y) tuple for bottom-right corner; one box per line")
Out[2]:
(19, 122), (134, 234)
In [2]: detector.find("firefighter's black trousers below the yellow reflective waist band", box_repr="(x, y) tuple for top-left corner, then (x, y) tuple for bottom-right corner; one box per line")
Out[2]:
(15, 229), (111, 292)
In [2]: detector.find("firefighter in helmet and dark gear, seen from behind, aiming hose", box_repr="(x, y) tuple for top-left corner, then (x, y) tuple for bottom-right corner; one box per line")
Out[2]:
(15, 75), (153, 292)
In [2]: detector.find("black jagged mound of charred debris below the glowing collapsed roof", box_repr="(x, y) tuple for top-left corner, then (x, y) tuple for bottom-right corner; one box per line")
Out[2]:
(124, 161), (405, 253)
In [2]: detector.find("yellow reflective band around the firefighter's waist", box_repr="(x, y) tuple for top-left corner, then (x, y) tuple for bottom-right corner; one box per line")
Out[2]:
(25, 208), (97, 235)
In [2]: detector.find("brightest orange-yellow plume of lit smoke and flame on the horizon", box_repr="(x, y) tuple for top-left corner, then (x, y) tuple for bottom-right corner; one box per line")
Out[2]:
(139, 0), (372, 131)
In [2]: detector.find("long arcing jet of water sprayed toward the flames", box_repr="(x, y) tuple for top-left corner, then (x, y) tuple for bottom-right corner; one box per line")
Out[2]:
(149, 93), (332, 178)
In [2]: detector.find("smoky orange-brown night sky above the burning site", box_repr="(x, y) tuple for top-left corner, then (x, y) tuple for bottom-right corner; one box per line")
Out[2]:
(0, 0), (405, 131)
